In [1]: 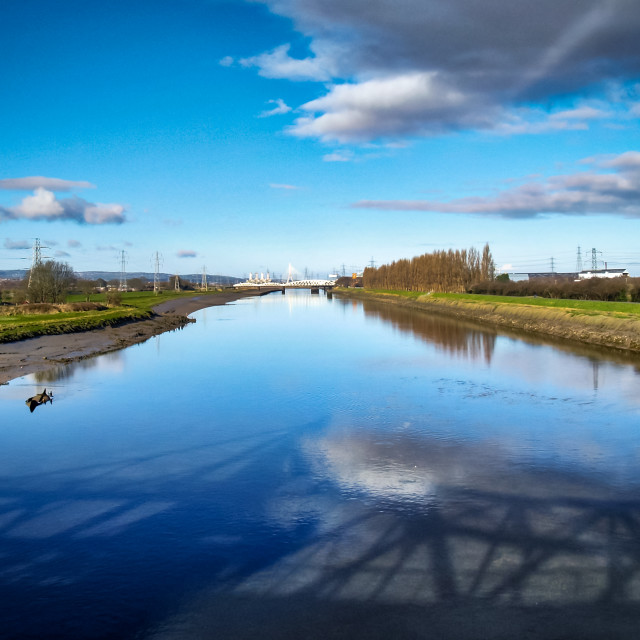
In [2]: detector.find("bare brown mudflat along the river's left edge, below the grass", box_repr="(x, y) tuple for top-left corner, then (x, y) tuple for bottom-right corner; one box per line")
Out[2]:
(0, 291), (260, 384)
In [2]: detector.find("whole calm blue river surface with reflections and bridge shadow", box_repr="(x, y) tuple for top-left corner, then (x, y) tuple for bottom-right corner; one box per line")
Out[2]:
(0, 292), (640, 640)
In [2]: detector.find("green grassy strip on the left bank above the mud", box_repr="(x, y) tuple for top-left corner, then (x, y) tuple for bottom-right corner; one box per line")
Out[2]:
(0, 291), (210, 343)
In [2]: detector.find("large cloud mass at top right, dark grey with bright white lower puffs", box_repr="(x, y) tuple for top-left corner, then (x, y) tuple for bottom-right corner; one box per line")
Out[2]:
(246, 0), (640, 141)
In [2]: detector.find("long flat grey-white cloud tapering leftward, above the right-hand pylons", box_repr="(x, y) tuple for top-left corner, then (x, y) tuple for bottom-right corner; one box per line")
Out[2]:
(352, 151), (640, 218)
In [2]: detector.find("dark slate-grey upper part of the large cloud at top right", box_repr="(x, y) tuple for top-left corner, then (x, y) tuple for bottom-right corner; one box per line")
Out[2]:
(261, 0), (640, 95)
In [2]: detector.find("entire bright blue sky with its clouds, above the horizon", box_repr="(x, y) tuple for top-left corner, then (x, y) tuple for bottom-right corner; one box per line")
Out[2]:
(0, 0), (640, 276)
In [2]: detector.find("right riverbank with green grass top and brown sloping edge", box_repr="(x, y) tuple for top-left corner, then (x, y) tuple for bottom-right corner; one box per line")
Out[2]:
(334, 289), (640, 353)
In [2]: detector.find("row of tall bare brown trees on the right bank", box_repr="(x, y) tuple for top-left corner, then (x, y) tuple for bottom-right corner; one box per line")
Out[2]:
(362, 244), (495, 293)
